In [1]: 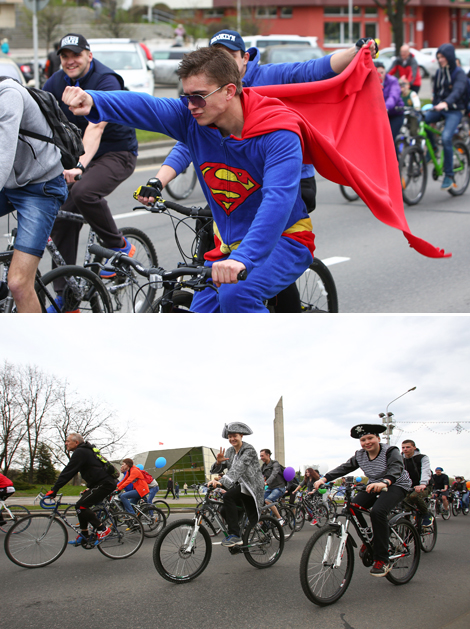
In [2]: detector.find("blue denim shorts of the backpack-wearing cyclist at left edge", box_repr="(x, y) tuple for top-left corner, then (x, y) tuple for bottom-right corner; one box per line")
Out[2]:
(0, 174), (68, 258)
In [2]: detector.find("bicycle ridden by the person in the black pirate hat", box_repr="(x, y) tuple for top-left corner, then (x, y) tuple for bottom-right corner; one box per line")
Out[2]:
(300, 481), (421, 606)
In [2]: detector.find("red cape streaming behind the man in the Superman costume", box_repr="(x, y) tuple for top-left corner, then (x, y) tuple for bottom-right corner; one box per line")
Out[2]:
(242, 48), (451, 258)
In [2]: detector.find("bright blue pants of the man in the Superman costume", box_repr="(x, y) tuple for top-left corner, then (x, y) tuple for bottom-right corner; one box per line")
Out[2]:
(191, 236), (312, 312)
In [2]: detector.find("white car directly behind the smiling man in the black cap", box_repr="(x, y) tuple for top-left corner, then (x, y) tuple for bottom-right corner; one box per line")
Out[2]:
(88, 39), (155, 96)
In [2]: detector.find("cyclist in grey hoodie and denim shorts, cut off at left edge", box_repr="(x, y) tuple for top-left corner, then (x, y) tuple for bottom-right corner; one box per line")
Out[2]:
(0, 79), (67, 312)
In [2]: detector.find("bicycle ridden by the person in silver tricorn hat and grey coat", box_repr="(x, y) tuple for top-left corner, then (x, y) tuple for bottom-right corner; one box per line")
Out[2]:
(153, 488), (284, 584)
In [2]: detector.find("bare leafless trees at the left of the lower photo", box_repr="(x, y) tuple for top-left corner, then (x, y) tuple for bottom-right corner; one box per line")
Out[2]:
(0, 361), (127, 483)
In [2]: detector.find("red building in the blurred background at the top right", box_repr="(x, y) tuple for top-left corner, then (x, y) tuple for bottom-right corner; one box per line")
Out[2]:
(201, 0), (470, 49)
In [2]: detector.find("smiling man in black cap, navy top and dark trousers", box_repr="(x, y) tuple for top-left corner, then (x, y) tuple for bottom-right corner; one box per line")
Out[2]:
(43, 33), (137, 302)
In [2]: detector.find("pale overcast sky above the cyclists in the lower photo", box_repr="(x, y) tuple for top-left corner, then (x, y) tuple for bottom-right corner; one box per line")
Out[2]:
(0, 315), (470, 478)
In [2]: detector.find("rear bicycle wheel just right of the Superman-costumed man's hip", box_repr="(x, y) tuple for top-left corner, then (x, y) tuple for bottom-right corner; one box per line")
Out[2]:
(296, 258), (338, 313)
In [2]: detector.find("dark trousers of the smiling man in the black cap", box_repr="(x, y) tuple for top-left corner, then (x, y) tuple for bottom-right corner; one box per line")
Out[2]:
(51, 151), (137, 264)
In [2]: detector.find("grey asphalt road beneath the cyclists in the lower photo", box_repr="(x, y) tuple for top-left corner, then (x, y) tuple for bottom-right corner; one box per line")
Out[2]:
(0, 515), (470, 629)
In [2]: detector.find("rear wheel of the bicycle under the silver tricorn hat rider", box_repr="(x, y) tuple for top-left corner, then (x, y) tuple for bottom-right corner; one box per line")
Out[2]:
(243, 515), (285, 570)
